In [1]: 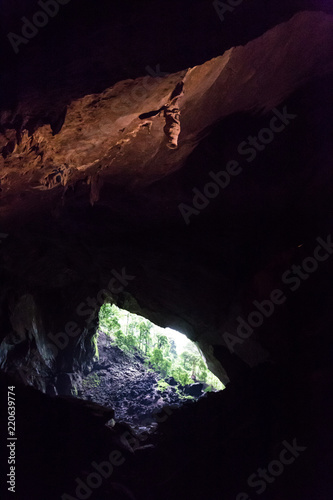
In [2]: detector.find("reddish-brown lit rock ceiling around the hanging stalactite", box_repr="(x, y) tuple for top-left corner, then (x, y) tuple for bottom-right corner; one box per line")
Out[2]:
(0, 12), (333, 216)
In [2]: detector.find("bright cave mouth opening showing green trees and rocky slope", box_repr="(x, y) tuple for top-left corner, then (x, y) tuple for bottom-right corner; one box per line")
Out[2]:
(78, 303), (224, 432)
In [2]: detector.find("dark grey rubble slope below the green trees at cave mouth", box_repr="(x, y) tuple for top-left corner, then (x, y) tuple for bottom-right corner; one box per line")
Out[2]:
(75, 331), (206, 432)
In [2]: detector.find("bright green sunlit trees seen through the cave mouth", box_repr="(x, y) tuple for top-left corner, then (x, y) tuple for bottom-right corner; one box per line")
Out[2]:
(99, 304), (224, 392)
